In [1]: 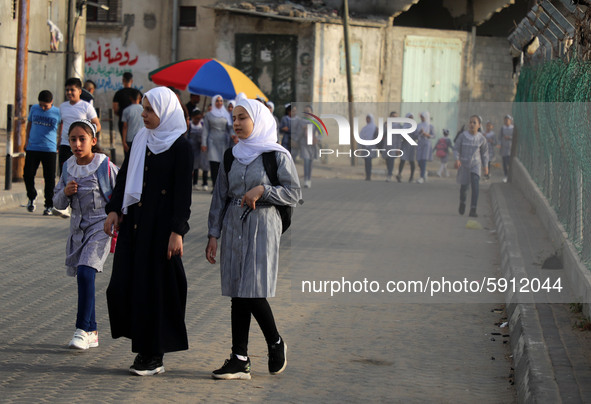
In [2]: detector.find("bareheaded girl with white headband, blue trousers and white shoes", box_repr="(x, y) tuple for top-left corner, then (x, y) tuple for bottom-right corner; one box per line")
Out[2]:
(53, 120), (118, 350)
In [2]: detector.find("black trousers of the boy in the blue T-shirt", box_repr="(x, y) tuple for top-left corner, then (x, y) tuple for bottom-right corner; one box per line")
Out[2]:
(23, 151), (56, 208)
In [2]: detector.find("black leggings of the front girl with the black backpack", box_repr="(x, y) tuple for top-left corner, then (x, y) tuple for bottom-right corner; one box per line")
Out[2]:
(232, 297), (279, 356)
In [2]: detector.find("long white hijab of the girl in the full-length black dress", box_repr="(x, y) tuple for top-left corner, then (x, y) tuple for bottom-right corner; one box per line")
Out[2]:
(122, 87), (187, 214)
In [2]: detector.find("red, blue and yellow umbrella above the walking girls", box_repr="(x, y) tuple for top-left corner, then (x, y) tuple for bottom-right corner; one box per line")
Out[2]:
(148, 59), (267, 100)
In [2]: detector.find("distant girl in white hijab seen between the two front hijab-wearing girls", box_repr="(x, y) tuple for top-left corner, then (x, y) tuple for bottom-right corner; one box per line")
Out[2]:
(201, 95), (233, 188)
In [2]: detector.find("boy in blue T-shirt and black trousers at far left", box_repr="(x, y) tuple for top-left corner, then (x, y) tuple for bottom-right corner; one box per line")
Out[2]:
(23, 90), (61, 216)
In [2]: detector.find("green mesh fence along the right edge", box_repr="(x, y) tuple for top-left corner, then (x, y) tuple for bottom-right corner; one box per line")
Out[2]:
(513, 55), (591, 269)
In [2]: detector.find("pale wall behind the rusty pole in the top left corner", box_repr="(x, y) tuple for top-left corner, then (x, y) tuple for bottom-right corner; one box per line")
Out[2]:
(0, 0), (68, 129)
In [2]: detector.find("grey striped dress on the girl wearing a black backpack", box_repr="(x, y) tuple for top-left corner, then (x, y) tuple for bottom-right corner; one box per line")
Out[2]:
(208, 152), (301, 297)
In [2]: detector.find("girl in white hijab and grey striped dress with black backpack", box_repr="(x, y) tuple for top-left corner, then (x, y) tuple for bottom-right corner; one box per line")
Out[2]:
(205, 100), (301, 379)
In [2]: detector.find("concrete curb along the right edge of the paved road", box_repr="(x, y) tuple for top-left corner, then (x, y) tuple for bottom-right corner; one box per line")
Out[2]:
(490, 184), (561, 403)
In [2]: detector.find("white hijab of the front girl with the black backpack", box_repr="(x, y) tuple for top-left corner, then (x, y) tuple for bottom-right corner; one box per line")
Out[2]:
(232, 99), (291, 165)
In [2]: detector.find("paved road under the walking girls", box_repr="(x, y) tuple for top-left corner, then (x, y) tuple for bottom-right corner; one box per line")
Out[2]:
(0, 175), (515, 403)
